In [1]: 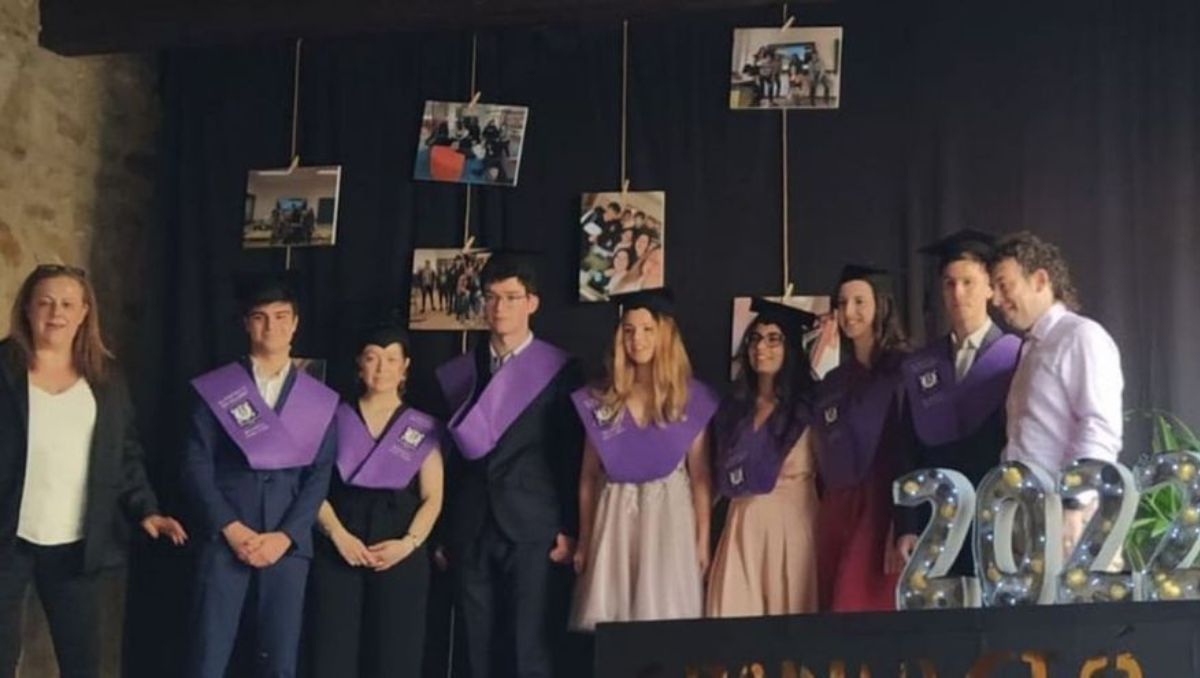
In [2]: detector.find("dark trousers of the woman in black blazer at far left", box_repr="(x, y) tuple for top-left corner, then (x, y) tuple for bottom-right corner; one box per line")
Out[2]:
(0, 539), (100, 678)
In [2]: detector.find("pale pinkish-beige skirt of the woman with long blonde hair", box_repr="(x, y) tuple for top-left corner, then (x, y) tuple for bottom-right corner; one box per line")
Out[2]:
(570, 464), (703, 630)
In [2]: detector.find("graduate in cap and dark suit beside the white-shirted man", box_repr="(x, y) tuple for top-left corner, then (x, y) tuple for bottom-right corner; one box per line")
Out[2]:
(895, 230), (1020, 576)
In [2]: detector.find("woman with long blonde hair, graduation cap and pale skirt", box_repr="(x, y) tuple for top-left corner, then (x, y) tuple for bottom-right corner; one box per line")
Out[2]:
(571, 292), (716, 630)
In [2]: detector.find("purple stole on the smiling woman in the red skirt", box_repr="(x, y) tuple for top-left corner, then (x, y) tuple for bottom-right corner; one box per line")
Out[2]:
(812, 359), (899, 488)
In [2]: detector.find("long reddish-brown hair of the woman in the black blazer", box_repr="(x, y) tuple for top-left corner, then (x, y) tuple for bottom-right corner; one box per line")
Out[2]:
(8, 264), (113, 384)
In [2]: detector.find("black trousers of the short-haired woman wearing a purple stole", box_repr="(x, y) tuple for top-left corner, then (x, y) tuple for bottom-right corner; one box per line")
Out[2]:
(307, 536), (430, 678)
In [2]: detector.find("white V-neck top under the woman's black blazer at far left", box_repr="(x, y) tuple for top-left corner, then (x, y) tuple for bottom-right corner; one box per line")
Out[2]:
(17, 379), (96, 546)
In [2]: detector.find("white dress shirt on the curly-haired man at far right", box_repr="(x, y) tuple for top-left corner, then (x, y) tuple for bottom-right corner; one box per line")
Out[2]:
(1004, 304), (1124, 473)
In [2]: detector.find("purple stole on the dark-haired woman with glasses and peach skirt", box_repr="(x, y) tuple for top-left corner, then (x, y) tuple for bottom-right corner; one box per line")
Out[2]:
(713, 400), (809, 498)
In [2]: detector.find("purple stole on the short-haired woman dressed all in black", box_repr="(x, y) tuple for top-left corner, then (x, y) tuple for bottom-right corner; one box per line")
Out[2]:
(337, 403), (442, 490)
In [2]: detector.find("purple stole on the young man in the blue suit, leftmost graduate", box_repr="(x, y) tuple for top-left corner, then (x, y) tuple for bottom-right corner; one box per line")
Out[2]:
(192, 362), (337, 470)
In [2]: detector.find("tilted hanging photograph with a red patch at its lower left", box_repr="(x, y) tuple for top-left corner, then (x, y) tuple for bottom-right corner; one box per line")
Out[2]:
(413, 101), (529, 186)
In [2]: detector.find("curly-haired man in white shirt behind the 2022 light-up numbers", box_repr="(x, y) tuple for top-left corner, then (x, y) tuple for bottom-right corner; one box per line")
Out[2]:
(991, 232), (1124, 545)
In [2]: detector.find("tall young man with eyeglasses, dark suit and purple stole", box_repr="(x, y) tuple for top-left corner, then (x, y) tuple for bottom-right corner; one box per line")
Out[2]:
(438, 253), (582, 678)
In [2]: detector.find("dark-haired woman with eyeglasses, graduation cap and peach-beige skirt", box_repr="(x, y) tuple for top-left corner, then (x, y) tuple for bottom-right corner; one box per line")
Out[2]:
(706, 299), (817, 617)
